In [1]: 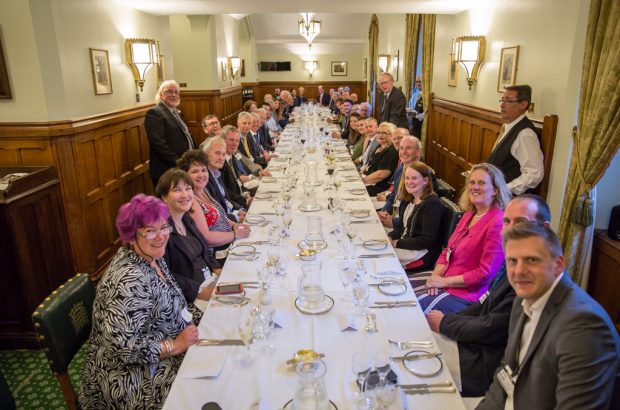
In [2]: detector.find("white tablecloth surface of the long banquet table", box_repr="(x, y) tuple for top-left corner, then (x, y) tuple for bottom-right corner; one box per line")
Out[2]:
(164, 118), (465, 410)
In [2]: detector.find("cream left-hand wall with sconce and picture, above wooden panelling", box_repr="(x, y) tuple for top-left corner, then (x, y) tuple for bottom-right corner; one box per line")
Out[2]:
(0, 0), (172, 121)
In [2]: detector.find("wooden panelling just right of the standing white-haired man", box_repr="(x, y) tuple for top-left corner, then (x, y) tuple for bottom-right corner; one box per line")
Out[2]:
(179, 85), (243, 144)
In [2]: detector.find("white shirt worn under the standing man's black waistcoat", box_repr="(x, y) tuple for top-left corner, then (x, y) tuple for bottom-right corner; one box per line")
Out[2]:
(493, 114), (545, 195)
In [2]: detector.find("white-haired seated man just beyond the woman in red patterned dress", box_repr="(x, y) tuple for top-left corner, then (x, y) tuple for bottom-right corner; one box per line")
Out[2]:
(204, 137), (247, 222)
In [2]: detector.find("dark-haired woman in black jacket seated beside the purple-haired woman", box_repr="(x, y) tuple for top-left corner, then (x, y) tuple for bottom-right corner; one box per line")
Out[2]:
(156, 168), (221, 303)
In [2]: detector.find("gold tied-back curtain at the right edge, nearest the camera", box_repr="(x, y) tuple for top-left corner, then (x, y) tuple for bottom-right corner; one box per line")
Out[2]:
(559, 0), (620, 286)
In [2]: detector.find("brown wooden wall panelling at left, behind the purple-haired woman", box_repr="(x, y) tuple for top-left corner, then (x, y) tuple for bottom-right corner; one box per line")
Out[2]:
(0, 104), (153, 273)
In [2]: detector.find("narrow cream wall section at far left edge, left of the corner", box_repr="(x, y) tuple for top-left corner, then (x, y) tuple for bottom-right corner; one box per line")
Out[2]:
(0, 1), (48, 122)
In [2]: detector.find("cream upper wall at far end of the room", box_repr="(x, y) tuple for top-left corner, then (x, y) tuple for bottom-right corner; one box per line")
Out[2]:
(258, 54), (364, 85)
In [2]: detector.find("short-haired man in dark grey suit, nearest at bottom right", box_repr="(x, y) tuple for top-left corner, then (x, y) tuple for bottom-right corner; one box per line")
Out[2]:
(477, 222), (620, 410)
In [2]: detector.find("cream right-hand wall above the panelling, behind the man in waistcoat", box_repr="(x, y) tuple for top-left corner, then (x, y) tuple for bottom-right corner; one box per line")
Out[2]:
(432, 0), (588, 228)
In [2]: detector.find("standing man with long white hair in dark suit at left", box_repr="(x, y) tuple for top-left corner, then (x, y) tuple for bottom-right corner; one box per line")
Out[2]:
(144, 80), (195, 187)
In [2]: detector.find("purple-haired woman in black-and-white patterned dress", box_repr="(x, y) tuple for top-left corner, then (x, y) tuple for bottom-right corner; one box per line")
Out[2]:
(78, 194), (198, 409)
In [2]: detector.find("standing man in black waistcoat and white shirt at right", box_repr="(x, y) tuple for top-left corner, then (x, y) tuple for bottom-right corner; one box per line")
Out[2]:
(487, 85), (545, 195)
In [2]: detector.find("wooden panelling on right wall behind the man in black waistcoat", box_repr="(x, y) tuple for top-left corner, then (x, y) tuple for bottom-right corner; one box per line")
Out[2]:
(425, 95), (558, 198)
